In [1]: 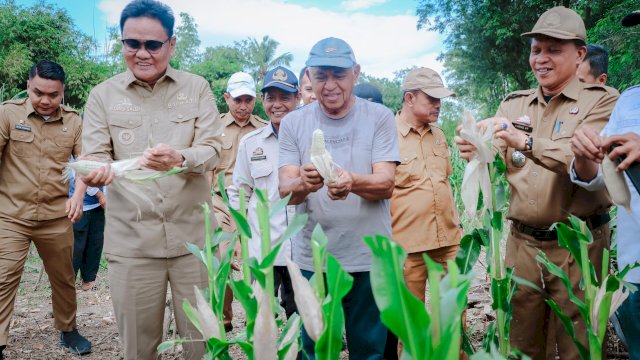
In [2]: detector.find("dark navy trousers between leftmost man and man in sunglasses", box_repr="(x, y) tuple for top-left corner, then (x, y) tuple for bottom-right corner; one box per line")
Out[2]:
(73, 206), (104, 282)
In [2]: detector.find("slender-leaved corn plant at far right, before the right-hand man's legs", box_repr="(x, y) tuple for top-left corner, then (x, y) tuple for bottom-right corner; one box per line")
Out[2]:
(518, 215), (640, 360)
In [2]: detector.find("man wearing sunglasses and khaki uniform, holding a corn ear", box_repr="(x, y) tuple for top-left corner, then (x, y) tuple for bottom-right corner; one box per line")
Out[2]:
(82, 0), (221, 359)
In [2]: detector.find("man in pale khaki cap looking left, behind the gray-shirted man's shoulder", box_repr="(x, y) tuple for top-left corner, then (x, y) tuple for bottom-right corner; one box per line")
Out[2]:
(391, 68), (462, 358)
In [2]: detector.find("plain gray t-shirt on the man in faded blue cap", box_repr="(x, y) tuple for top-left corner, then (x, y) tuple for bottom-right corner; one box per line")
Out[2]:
(278, 98), (400, 272)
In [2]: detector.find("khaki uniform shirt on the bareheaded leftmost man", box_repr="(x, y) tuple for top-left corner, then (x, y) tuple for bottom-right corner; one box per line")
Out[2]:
(0, 99), (82, 221)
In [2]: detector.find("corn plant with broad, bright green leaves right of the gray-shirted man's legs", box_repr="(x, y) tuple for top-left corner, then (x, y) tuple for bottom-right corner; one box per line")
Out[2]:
(364, 235), (475, 360)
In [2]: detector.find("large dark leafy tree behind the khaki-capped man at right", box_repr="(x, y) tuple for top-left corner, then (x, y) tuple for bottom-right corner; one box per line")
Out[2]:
(416, 0), (638, 116)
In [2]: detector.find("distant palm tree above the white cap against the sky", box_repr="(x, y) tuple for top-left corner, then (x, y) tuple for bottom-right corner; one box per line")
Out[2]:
(237, 35), (293, 82)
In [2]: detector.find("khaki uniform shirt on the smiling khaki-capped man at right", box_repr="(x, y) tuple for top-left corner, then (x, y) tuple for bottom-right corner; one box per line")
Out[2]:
(496, 77), (619, 227)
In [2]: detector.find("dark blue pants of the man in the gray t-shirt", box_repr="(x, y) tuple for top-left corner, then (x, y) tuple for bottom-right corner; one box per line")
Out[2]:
(302, 270), (387, 360)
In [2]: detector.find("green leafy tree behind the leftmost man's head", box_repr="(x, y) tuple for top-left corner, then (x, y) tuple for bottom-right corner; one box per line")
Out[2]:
(0, 0), (110, 108)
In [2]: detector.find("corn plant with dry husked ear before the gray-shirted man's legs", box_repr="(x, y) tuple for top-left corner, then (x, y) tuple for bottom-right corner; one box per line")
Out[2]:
(287, 224), (353, 360)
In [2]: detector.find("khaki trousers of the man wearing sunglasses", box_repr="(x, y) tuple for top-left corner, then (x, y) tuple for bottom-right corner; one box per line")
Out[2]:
(107, 254), (208, 360)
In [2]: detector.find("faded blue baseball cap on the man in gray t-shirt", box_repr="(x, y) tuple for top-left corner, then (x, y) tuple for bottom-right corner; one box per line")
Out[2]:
(305, 37), (356, 68)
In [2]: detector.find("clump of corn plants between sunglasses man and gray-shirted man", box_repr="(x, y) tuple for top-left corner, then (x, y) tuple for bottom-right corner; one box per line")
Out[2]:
(158, 181), (307, 360)
